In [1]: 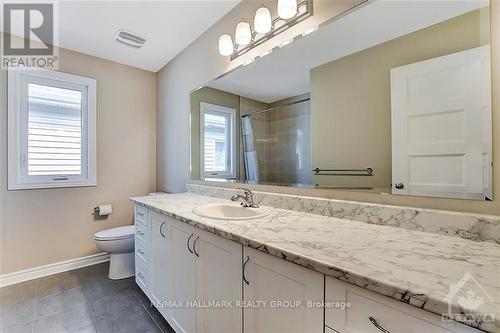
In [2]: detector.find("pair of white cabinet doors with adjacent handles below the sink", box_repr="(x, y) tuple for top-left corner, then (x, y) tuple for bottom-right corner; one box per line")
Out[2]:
(167, 220), (242, 333)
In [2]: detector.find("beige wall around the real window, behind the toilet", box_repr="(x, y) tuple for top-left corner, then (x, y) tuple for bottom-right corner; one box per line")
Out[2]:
(0, 42), (156, 274)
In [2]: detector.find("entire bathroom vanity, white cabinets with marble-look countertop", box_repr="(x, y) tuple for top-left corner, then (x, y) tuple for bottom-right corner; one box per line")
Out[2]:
(131, 187), (500, 333)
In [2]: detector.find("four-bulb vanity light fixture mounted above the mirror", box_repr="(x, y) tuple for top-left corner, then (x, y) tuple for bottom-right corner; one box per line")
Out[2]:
(219, 0), (317, 60)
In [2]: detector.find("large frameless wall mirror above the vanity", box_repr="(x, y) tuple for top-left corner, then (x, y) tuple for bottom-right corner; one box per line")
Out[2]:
(191, 1), (492, 200)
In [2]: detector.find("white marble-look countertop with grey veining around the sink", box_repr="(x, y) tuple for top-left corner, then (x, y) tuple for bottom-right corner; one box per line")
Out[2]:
(131, 193), (500, 332)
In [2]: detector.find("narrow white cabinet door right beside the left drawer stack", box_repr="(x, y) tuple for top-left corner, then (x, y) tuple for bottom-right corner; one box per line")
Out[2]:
(149, 212), (171, 317)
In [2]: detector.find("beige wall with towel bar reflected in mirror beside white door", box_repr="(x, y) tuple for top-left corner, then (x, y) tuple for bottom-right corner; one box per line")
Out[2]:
(311, 8), (490, 192)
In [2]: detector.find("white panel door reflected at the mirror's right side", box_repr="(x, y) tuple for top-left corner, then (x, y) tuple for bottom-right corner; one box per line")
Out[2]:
(391, 45), (493, 199)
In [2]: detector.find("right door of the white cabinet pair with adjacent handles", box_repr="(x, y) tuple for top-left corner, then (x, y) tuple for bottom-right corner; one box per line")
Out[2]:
(193, 230), (243, 333)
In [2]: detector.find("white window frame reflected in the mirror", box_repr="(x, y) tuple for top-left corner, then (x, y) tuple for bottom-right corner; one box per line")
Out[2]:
(200, 102), (237, 179)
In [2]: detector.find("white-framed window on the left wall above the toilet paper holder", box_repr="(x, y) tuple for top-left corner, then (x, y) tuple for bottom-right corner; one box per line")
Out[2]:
(8, 70), (96, 190)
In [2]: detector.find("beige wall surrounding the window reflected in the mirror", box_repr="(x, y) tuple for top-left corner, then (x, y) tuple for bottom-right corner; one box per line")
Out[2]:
(191, 87), (240, 179)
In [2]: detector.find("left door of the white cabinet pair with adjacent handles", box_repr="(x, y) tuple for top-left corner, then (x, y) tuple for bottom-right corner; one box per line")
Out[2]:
(169, 221), (196, 333)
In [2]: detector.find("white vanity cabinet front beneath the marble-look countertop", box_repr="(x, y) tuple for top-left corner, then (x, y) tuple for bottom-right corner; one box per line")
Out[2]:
(135, 201), (479, 333)
